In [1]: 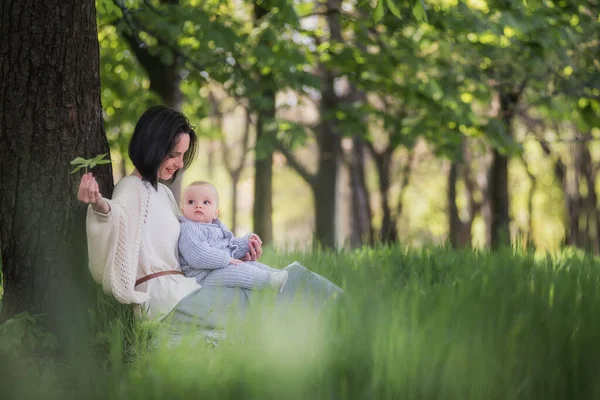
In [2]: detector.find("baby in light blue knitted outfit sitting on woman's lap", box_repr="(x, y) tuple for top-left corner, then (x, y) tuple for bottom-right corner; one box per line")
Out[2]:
(179, 181), (288, 292)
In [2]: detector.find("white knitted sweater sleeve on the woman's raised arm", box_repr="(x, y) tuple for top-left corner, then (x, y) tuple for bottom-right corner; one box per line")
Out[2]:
(86, 177), (150, 304)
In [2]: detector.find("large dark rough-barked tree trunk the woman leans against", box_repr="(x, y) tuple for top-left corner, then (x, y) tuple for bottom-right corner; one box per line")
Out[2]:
(0, 0), (112, 345)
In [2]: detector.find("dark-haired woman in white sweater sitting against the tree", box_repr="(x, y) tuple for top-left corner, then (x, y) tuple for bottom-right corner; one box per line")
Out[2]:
(78, 106), (341, 328)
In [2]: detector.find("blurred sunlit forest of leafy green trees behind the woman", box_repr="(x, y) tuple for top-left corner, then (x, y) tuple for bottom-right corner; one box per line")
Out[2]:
(97, 0), (600, 252)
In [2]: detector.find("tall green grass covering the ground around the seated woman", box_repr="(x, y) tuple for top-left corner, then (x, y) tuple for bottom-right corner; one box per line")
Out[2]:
(0, 247), (600, 399)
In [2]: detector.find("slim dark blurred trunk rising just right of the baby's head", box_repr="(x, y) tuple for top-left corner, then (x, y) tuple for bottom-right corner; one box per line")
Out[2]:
(250, 2), (275, 244)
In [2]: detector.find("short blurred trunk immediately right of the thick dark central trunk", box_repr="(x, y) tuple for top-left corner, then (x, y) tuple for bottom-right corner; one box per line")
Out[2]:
(349, 136), (374, 247)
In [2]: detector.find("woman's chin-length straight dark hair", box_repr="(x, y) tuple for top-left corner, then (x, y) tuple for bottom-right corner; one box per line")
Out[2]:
(129, 106), (197, 189)
